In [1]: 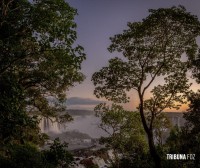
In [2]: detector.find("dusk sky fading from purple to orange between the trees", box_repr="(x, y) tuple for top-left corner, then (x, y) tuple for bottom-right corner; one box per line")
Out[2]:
(66, 0), (200, 111)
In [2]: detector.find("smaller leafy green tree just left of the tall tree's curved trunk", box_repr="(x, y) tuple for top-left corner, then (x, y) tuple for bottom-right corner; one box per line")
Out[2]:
(95, 103), (147, 167)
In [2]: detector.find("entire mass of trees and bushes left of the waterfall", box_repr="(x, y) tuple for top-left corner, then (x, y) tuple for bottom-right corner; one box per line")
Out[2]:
(0, 0), (85, 168)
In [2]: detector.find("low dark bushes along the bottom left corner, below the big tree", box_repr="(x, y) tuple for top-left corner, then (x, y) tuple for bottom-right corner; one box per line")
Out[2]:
(0, 139), (73, 168)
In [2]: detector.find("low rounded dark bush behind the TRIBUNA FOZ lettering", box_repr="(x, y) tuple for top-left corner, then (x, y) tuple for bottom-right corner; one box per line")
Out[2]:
(162, 126), (199, 168)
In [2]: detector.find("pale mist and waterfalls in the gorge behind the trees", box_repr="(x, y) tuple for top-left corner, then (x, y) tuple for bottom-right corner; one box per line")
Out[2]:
(40, 110), (185, 138)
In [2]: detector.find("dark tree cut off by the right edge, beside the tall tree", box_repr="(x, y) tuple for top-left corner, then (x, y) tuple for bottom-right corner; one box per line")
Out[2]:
(183, 18), (200, 167)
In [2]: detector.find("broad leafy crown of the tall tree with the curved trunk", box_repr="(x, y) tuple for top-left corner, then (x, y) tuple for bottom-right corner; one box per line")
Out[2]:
(92, 7), (200, 105)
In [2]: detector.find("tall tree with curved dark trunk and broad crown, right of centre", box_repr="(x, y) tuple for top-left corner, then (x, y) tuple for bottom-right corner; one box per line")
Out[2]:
(92, 6), (200, 167)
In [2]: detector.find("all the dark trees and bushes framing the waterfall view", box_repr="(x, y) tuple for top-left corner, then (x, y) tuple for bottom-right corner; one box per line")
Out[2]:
(0, 0), (200, 168)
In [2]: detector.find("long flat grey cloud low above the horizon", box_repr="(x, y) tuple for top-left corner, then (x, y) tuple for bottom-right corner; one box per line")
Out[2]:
(67, 97), (105, 105)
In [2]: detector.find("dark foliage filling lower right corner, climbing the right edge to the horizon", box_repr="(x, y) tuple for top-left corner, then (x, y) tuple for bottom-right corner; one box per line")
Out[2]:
(165, 91), (200, 168)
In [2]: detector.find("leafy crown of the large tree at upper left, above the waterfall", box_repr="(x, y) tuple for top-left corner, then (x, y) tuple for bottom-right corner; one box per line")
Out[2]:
(0, 0), (85, 120)
